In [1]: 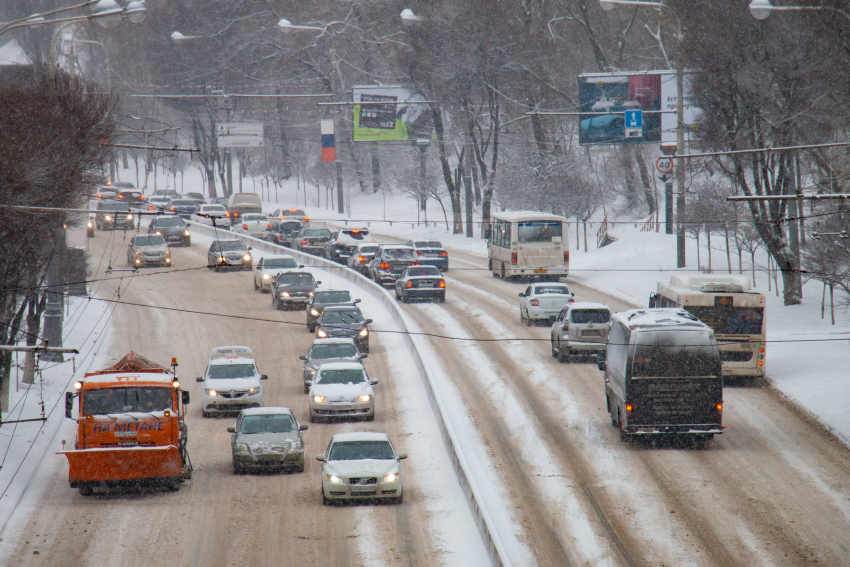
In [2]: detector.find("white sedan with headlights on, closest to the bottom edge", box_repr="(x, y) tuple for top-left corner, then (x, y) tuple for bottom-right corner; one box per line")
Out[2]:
(316, 432), (407, 506)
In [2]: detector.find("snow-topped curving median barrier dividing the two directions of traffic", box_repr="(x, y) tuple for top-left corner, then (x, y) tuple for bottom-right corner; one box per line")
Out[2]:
(187, 221), (511, 567)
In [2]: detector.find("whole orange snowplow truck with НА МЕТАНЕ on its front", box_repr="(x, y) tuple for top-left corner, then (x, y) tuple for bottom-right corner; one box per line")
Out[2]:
(58, 352), (192, 496)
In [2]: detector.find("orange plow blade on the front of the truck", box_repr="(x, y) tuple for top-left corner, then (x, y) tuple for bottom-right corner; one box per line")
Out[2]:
(57, 445), (183, 486)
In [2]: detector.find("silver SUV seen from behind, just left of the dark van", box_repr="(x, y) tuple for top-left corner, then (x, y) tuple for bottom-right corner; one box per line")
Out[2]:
(551, 302), (611, 362)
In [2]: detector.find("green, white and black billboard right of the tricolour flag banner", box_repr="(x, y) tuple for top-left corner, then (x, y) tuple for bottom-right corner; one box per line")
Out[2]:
(352, 86), (434, 142)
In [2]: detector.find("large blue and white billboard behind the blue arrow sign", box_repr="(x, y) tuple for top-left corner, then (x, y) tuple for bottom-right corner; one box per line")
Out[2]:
(579, 71), (699, 144)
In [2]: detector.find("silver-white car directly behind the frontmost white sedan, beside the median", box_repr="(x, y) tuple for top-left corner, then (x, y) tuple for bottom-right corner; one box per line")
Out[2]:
(304, 362), (378, 422)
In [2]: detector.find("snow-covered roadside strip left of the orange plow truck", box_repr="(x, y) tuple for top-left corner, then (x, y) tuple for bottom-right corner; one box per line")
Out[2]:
(0, 292), (112, 541)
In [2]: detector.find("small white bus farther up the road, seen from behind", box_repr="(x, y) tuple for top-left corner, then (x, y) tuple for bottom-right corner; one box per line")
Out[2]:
(485, 211), (570, 281)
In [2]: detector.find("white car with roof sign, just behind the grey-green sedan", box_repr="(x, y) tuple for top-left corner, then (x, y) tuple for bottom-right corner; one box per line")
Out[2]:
(196, 346), (269, 417)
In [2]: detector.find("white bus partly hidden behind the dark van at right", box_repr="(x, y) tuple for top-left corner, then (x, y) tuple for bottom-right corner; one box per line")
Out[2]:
(649, 274), (766, 377)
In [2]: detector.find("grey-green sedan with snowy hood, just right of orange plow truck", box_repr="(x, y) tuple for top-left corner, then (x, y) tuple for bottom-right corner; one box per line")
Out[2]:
(227, 407), (307, 474)
